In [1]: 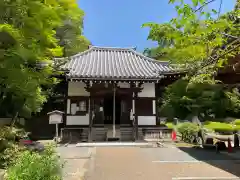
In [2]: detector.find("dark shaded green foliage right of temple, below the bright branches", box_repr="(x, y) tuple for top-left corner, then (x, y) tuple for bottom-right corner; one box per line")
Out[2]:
(160, 78), (240, 119)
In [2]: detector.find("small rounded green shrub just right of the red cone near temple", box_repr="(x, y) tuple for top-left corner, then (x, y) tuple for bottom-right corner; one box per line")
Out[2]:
(177, 122), (200, 142)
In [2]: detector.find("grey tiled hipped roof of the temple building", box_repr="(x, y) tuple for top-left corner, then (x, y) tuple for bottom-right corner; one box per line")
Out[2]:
(62, 46), (174, 79)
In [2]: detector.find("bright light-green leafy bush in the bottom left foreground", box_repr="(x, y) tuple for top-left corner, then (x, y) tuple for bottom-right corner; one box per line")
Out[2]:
(6, 143), (62, 180)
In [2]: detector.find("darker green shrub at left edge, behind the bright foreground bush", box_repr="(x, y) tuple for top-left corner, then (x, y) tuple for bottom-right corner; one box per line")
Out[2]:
(0, 126), (26, 167)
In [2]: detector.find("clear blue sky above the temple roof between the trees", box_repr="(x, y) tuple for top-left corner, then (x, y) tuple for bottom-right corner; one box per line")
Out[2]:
(78, 0), (236, 51)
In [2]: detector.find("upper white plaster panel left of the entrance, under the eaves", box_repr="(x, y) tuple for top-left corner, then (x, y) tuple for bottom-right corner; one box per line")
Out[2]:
(68, 82), (89, 96)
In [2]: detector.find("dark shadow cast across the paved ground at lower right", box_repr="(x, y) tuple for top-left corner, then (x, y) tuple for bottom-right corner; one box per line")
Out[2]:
(178, 147), (240, 177)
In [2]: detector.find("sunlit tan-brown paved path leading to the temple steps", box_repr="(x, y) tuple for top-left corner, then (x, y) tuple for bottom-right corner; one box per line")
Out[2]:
(84, 147), (239, 180)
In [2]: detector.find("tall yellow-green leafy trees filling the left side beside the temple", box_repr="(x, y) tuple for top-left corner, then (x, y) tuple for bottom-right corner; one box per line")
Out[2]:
(0, 0), (89, 117)
